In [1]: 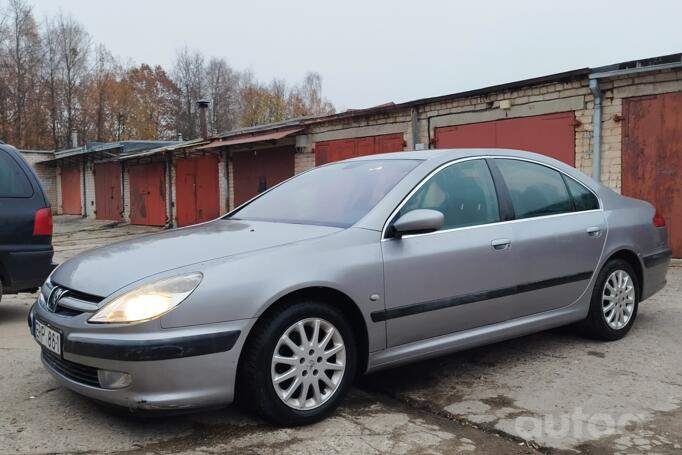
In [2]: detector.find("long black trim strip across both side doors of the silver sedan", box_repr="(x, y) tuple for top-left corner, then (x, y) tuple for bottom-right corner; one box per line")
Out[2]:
(370, 272), (592, 322)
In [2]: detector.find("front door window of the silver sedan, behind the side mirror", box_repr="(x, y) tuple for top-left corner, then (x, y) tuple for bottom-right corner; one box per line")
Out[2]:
(398, 160), (500, 229)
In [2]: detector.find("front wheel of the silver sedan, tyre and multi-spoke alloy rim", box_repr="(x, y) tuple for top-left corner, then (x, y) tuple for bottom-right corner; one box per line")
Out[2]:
(237, 301), (357, 426)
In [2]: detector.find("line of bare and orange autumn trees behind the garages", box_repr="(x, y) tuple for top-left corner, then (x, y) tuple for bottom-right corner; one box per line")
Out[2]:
(0, 4), (334, 150)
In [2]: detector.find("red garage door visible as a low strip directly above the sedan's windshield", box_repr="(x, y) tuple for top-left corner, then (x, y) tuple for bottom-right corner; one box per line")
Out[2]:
(315, 133), (405, 166)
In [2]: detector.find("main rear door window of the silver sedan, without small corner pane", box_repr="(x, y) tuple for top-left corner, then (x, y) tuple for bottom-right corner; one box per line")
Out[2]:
(495, 159), (573, 219)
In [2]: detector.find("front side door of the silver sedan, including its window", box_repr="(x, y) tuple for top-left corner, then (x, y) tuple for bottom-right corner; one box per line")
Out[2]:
(373, 159), (519, 346)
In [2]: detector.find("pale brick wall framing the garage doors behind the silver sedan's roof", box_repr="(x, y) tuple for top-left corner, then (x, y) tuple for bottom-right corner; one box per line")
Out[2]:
(296, 69), (682, 191)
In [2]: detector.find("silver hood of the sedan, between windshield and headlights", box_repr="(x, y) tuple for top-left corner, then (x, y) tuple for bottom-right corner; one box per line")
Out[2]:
(51, 220), (341, 297)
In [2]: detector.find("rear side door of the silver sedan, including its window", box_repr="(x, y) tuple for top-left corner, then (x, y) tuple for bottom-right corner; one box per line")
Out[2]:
(494, 158), (606, 318)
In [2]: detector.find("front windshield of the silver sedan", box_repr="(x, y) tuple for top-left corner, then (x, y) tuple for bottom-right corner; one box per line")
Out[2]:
(228, 160), (421, 227)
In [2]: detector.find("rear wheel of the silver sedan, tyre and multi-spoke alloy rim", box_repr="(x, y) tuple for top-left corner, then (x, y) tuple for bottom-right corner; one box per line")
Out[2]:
(586, 259), (639, 341)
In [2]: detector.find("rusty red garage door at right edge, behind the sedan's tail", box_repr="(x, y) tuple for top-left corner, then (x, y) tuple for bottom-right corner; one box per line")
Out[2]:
(622, 93), (682, 258)
